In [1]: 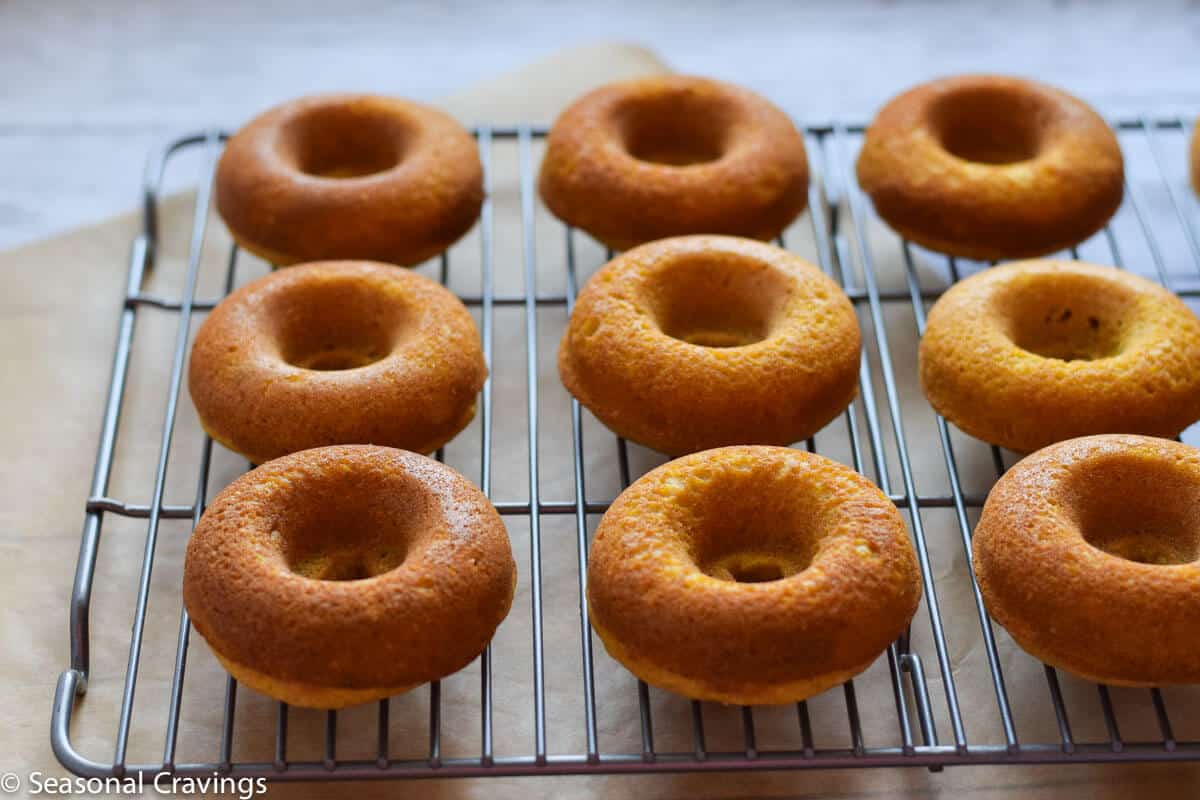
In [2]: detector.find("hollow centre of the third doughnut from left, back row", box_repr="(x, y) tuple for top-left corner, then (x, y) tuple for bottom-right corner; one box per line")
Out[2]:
(930, 86), (1048, 164)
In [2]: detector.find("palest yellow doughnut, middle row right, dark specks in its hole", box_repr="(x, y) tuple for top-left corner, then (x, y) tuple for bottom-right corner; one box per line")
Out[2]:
(919, 260), (1200, 452)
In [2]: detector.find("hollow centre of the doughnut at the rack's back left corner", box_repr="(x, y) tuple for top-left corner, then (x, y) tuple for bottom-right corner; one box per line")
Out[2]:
(281, 102), (409, 179)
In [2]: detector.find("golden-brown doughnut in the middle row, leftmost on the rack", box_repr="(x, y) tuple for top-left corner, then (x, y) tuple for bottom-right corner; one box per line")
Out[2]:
(187, 261), (487, 464)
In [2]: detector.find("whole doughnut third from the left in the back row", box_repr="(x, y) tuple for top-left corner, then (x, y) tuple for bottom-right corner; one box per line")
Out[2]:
(858, 76), (1124, 259)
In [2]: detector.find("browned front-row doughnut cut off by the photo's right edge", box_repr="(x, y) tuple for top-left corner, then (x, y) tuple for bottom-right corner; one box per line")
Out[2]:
(973, 434), (1200, 686)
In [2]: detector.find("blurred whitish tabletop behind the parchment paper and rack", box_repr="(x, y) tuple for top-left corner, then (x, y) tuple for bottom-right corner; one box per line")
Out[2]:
(0, 0), (1200, 248)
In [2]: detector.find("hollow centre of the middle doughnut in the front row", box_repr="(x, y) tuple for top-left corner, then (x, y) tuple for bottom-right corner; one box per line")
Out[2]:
(688, 462), (822, 583)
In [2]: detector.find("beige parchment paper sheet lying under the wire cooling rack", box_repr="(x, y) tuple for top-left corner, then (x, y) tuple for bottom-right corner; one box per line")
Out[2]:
(7, 40), (1200, 799)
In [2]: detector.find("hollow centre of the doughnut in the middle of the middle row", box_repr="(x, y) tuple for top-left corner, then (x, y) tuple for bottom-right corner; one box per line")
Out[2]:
(647, 253), (788, 348)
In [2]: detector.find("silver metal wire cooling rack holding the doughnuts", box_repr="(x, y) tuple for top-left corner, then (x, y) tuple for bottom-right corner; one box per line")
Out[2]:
(50, 118), (1200, 780)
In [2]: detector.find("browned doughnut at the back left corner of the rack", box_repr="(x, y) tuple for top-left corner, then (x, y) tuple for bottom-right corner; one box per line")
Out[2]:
(216, 95), (484, 266)
